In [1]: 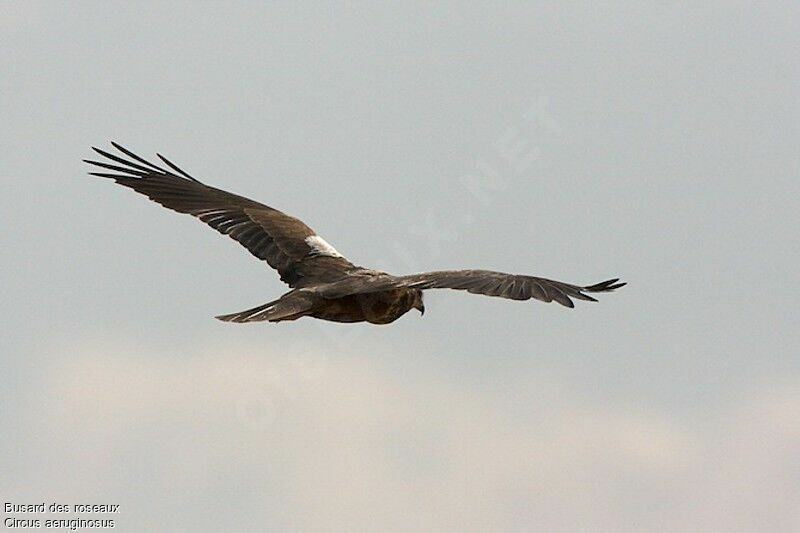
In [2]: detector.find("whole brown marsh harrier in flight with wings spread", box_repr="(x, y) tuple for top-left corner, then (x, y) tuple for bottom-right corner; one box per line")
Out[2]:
(84, 143), (625, 324)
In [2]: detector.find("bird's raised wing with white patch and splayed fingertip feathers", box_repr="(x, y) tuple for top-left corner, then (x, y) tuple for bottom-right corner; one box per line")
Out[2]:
(84, 142), (354, 287)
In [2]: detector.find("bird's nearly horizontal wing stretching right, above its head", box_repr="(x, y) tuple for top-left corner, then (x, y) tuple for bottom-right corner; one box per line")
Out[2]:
(319, 270), (625, 307)
